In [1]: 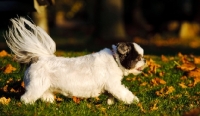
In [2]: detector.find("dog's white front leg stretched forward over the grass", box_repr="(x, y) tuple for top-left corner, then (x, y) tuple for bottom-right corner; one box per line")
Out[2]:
(106, 82), (139, 104)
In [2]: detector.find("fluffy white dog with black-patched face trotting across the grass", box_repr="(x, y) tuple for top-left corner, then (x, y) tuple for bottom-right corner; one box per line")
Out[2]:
(5, 17), (145, 104)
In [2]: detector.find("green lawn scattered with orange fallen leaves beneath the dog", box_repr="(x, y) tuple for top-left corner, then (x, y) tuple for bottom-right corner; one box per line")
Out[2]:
(0, 51), (200, 116)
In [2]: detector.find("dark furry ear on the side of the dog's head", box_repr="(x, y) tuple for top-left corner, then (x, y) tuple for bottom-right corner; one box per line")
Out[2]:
(117, 42), (131, 54)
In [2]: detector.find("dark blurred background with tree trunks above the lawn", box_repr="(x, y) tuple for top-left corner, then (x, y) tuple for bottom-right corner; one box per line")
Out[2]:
(0, 0), (200, 55)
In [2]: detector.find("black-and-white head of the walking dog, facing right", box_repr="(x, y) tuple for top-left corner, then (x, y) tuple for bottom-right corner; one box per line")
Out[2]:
(113, 42), (146, 75)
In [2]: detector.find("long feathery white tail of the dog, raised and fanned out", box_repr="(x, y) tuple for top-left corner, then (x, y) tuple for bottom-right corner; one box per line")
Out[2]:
(5, 17), (56, 63)
